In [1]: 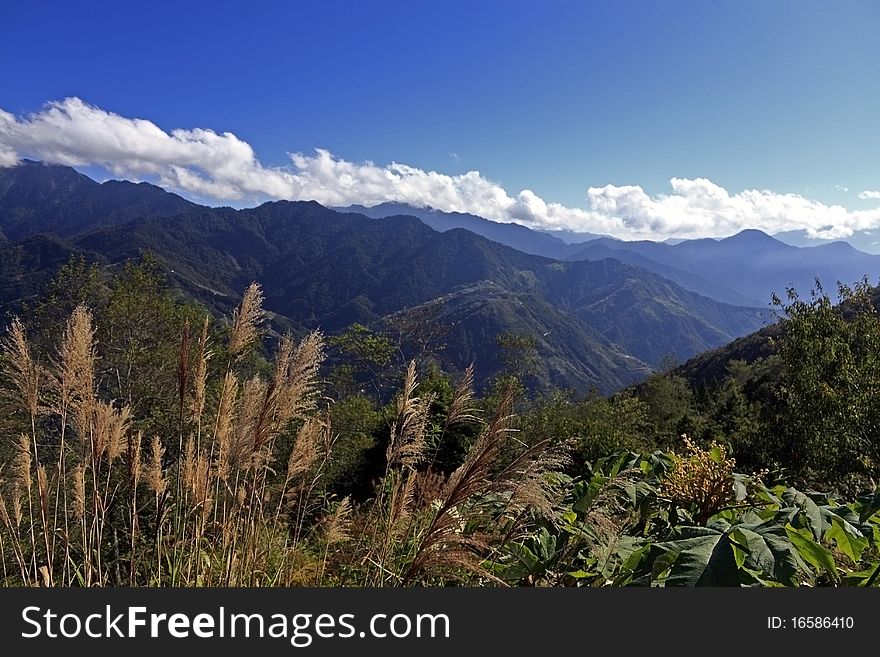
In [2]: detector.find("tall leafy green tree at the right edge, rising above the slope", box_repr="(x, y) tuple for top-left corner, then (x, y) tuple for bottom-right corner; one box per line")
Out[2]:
(771, 281), (880, 487)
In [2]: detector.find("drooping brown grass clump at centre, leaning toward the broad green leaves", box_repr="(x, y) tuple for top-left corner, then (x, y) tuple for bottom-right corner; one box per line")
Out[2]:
(330, 364), (564, 586)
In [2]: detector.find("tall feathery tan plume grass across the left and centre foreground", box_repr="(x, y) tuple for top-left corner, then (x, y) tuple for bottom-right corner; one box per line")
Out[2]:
(0, 284), (562, 586)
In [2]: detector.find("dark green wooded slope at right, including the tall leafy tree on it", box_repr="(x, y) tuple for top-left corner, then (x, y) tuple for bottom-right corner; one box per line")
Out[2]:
(635, 280), (880, 494)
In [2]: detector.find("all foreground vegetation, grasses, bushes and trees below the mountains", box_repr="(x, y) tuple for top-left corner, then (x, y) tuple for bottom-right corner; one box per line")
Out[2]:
(0, 258), (880, 586)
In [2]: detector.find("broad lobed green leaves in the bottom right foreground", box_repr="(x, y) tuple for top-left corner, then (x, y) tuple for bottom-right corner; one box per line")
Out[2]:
(494, 452), (880, 586)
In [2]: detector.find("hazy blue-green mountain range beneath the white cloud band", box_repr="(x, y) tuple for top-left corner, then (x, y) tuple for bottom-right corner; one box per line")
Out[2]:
(0, 161), (870, 392)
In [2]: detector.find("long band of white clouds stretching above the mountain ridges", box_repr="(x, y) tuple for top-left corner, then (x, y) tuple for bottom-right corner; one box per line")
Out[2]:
(0, 98), (880, 239)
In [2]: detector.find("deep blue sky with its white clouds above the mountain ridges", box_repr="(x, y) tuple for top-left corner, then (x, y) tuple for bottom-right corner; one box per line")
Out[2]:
(0, 0), (880, 237)
